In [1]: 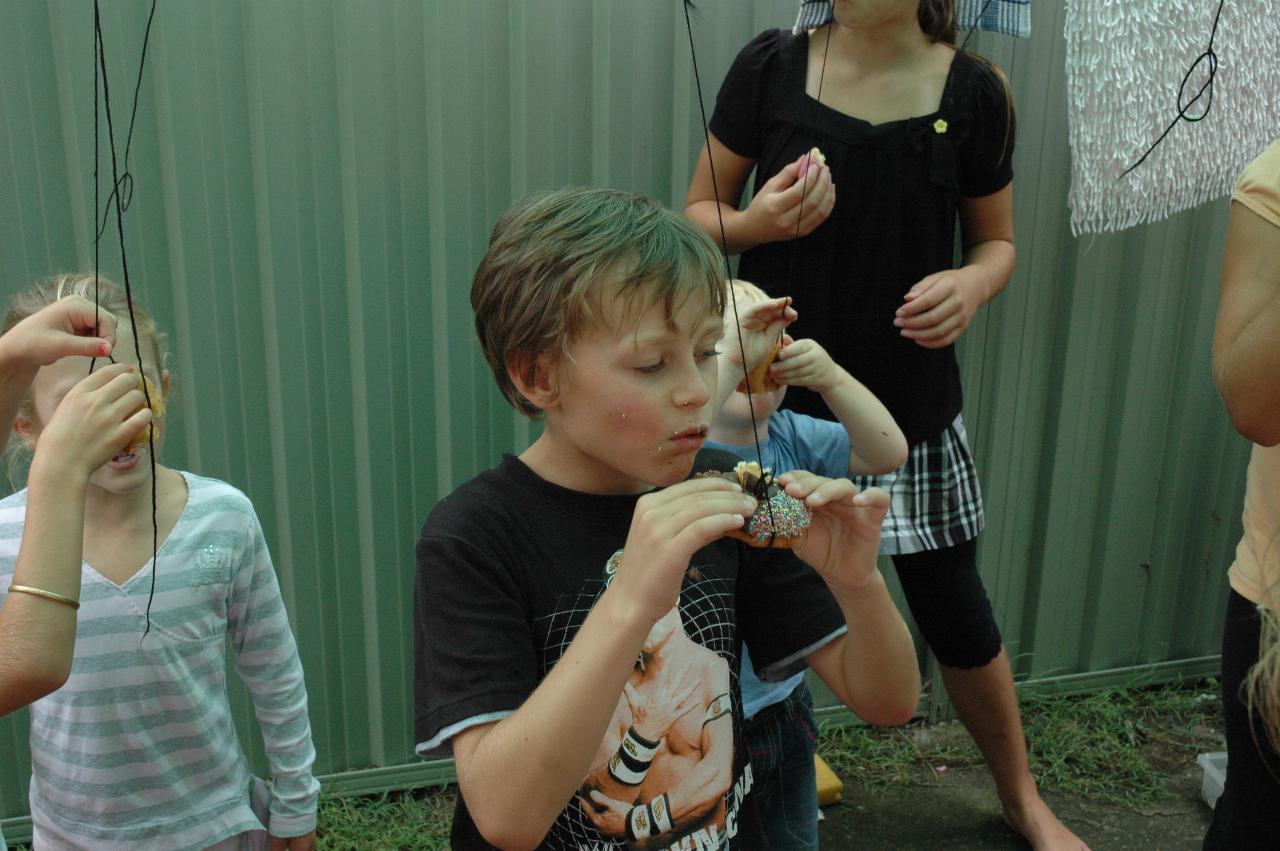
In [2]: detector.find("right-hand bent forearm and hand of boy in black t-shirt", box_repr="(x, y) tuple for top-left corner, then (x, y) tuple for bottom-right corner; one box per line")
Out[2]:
(780, 471), (920, 724)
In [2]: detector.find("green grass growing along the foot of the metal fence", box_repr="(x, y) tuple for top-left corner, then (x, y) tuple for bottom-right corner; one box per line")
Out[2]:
(296, 682), (1221, 851)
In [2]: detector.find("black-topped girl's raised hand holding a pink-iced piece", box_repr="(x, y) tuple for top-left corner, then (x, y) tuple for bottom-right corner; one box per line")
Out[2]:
(744, 152), (836, 244)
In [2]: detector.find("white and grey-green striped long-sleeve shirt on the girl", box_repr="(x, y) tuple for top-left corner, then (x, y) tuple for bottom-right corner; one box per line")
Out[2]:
(0, 473), (320, 850)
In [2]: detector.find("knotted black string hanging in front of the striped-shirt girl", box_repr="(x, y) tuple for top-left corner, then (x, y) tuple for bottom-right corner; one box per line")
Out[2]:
(93, 0), (160, 639)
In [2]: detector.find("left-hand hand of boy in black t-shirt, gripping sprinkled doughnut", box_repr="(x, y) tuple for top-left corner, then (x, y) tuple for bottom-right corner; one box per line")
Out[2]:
(609, 477), (755, 623)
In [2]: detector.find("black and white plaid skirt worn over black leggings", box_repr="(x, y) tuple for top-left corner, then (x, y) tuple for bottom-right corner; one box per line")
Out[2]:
(854, 416), (984, 555)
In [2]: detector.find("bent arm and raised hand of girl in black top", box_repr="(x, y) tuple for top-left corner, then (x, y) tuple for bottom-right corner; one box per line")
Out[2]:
(685, 134), (836, 255)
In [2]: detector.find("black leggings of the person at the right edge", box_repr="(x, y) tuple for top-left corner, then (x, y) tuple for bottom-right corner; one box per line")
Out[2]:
(1203, 591), (1280, 851)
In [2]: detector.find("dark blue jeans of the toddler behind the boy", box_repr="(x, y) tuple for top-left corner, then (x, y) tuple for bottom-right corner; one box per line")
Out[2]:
(746, 682), (818, 851)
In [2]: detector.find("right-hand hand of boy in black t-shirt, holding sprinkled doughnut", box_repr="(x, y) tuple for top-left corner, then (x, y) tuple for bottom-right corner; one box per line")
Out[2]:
(778, 470), (888, 589)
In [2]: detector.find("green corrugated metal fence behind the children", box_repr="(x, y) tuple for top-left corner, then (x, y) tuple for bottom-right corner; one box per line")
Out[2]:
(0, 0), (1248, 816)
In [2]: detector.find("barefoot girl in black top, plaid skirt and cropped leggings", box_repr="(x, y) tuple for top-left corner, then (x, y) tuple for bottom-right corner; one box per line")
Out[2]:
(685, 0), (1084, 850)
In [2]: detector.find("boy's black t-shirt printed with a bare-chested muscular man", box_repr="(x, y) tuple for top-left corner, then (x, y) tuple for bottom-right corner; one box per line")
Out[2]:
(413, 450), (845, 851)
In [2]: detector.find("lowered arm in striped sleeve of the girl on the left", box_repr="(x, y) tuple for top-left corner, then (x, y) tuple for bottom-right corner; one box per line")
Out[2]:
(227, 507), (320, 851)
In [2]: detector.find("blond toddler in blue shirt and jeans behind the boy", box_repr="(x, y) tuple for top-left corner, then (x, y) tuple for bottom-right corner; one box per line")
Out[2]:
(707, 280), (906, 851)
